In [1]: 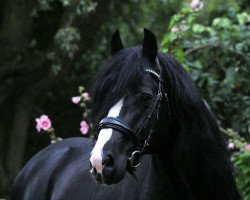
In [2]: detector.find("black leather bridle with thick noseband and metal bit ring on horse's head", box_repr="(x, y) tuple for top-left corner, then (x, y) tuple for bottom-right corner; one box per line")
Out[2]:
(99, 59), (171, 174)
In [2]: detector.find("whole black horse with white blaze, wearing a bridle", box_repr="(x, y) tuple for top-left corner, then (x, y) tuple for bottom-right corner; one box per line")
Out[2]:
(11, 29), (241, 200)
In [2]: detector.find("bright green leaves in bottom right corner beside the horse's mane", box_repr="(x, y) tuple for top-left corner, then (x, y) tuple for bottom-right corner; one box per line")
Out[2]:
(235, 150), (250, 200)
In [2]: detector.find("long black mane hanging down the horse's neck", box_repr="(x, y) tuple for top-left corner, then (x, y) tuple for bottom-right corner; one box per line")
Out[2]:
(158, 53), (239, 199)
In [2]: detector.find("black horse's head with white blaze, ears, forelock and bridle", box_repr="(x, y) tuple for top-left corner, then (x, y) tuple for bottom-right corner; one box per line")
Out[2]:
(90, 29), (170, 184)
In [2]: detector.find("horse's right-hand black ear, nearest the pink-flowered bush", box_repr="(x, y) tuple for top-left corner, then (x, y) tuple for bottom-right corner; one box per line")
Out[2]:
(143, 28), (158, 63)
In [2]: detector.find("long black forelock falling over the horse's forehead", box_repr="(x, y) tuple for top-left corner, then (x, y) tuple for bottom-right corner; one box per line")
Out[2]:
(91, 47), (150, 129)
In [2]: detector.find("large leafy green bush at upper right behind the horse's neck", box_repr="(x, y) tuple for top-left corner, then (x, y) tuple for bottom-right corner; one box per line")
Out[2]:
(162, 6), (250, 138)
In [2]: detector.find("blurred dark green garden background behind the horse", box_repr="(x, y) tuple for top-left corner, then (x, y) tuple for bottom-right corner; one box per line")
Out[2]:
(0, 0), (250, 199)
